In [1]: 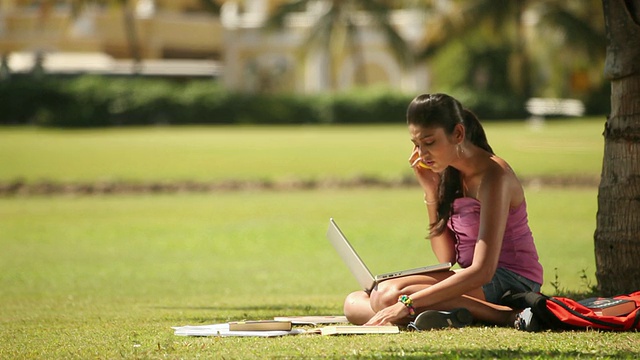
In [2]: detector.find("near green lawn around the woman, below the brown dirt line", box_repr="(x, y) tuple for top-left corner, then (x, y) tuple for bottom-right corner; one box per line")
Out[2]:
(0, 189), (640, 358)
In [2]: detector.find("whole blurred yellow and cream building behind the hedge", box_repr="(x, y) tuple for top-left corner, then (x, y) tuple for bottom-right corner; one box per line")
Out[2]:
(0, 0), (428, 92)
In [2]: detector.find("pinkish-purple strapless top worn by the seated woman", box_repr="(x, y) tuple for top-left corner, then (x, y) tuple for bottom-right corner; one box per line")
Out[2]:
(448, 197), (543, 284)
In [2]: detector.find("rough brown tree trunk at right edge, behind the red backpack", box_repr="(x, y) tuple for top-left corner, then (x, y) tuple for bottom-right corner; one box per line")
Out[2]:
(594, 0), (640, 295)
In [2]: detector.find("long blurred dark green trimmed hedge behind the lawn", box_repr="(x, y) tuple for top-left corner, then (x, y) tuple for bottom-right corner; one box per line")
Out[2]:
(0, 76), (524, 127)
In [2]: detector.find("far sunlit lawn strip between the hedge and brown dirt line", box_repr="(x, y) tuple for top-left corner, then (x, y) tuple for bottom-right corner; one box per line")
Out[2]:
(0, 118), (604, 182)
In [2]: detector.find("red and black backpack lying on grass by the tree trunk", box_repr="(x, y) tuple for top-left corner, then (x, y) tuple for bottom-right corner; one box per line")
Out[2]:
(504, 291), (640, 331)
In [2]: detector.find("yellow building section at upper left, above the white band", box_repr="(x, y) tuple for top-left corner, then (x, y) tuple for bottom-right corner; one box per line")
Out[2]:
(0, 0), (223, 59)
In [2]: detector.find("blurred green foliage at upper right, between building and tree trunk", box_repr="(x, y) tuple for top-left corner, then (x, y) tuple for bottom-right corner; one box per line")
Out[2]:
(417, 0), (609, 113)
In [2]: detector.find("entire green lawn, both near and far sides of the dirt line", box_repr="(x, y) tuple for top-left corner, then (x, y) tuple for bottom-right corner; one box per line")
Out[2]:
(0, 119), (640, 359)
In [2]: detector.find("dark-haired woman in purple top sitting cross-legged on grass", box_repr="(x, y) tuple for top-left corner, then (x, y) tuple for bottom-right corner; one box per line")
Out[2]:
(344, 94), (542, 329)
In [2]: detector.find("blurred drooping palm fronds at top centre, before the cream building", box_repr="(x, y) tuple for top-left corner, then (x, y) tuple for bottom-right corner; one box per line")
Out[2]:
(266, 0), (413, 89)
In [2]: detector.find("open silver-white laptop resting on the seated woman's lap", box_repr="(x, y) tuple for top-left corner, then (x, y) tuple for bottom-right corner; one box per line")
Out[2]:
(327, 218), (451, 292)
